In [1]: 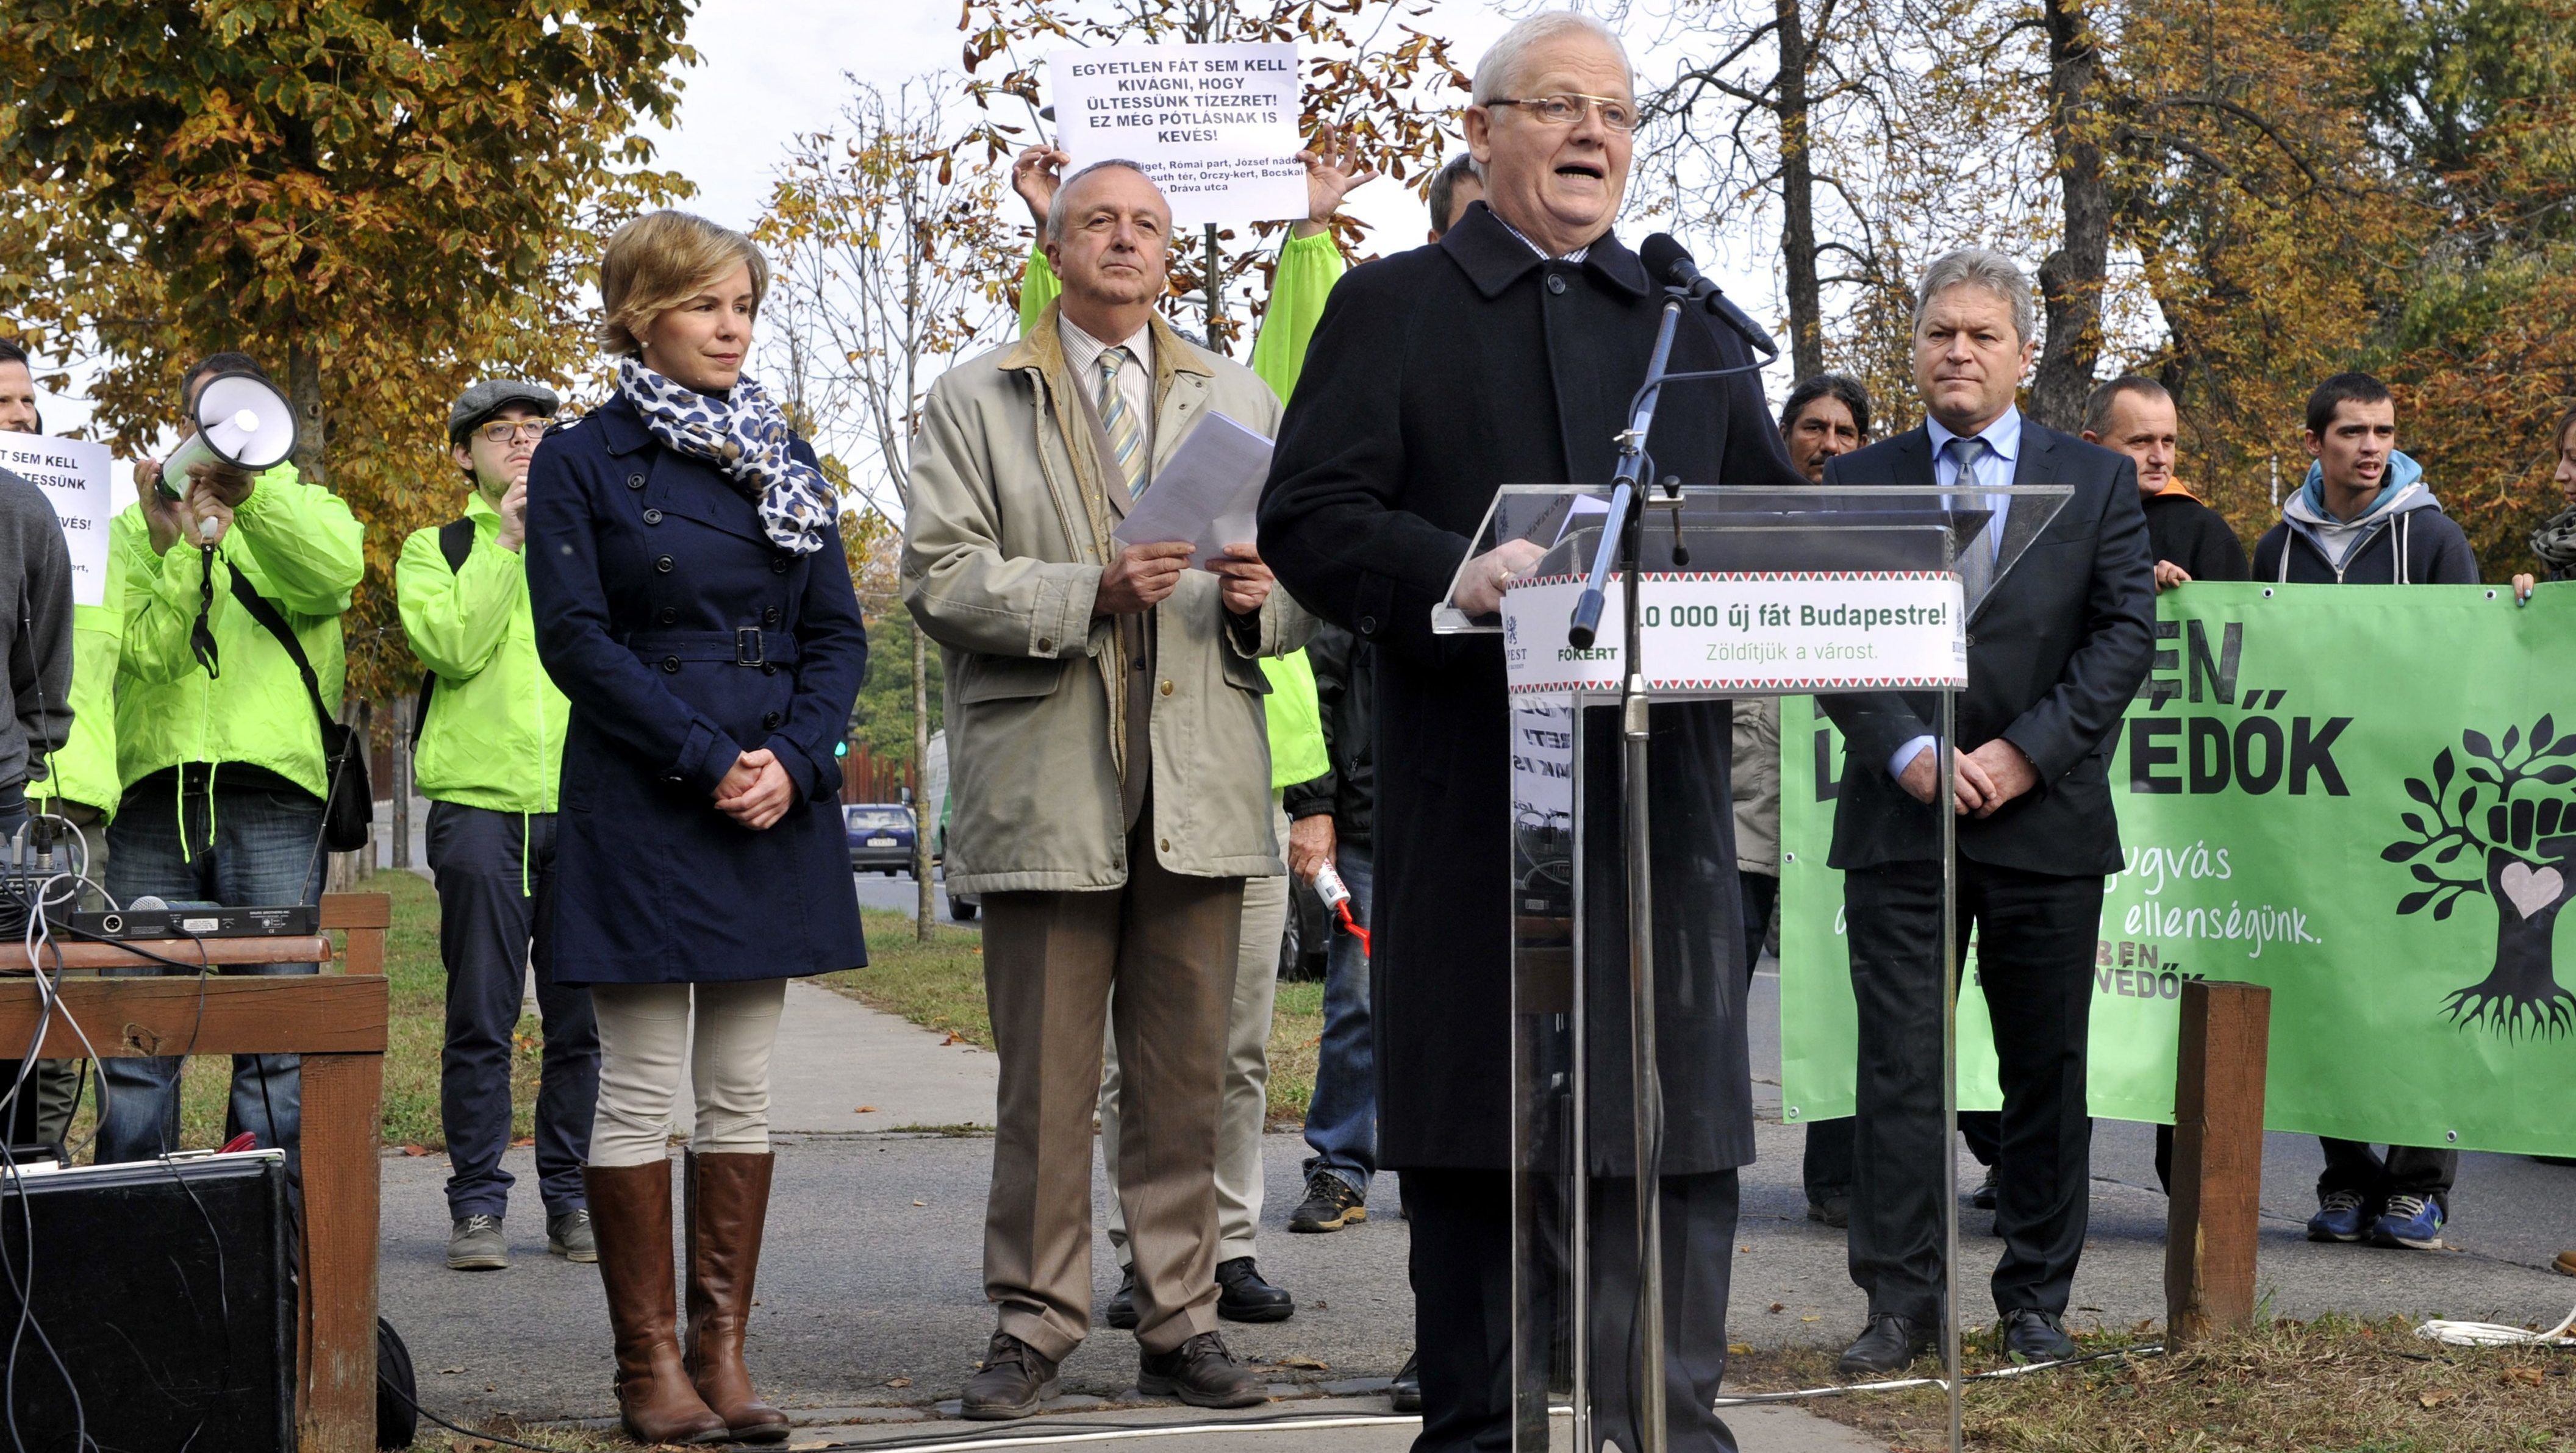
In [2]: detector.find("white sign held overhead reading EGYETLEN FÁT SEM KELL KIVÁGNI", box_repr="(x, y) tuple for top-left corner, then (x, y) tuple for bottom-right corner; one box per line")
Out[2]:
(1046, 44), (1306, 227)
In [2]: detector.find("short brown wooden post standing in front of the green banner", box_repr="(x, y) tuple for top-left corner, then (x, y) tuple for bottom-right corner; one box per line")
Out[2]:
(2164, 982), (2272, 1348)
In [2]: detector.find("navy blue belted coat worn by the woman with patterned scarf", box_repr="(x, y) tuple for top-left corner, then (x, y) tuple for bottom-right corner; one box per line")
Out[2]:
(526, 394), (868, 984)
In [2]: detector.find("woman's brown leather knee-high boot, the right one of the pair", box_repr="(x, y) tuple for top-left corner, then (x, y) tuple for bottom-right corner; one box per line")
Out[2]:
(688, 1152), (789, 1443)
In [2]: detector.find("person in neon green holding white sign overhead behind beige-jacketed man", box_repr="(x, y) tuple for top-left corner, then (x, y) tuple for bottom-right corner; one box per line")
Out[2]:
(1010, 129), (1378, 1327)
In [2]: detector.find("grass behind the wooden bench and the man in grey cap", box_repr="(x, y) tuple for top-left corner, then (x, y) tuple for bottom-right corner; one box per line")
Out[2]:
(72, 871), (541, 1152)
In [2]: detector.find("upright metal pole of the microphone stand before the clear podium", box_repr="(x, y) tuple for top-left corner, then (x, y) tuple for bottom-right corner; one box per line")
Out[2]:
(1620, 507), (1667, 1453)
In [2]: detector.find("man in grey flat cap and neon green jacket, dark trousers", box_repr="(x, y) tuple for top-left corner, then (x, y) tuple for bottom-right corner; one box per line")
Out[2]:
(394, 379), (600, 1270)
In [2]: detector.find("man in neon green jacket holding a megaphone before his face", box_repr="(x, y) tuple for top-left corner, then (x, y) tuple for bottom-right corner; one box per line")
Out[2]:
(98, 353), (366, 1167)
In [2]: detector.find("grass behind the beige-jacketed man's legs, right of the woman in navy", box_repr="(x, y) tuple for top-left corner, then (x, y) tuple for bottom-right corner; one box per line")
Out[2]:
(817, 909), (1324, 1126)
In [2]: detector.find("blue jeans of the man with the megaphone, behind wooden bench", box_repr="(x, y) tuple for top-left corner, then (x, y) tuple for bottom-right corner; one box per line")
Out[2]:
(98, 778), (322, 1177)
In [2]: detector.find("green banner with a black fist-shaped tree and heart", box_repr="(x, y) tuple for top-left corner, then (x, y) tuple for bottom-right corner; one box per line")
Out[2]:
(1780, 582), (2576, 1154)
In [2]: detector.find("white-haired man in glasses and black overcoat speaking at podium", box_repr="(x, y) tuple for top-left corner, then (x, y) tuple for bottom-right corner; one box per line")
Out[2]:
(1262, 13), (1798, 1451)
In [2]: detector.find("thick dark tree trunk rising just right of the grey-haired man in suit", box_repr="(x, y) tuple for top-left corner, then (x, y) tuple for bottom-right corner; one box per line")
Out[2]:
(2030, 0), (2109, 433)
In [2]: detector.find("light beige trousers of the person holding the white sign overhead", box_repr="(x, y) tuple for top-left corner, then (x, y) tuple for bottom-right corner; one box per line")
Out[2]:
(1100, 793), (1288, 1265)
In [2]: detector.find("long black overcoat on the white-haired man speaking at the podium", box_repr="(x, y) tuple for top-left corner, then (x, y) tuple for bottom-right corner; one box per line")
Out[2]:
(1260, 204), (1801, 1169)
